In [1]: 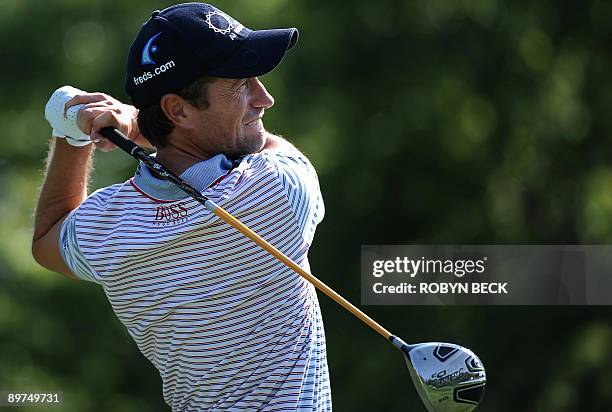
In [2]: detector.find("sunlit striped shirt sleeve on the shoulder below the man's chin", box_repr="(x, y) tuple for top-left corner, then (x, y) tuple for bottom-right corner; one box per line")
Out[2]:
(262, 150), (325, 245)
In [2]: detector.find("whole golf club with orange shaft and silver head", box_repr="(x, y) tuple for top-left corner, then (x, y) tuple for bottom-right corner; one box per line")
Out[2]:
(100, 127), (486, 412)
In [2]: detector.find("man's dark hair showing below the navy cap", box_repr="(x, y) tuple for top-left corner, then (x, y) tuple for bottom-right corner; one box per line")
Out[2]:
(137, 77), (213, 148)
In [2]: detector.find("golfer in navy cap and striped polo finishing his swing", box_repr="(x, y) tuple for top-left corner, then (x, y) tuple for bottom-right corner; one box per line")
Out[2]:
(32, 3), (331, 411)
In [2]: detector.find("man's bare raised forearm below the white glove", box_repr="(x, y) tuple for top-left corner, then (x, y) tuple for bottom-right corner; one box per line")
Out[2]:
(33, 138), (94, 242)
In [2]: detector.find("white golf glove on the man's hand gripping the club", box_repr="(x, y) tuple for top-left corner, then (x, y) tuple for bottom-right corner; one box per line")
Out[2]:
(45, 86), (91, 147)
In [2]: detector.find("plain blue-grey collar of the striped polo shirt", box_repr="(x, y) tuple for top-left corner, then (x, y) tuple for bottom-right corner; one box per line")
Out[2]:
(132, 154), (234, 201)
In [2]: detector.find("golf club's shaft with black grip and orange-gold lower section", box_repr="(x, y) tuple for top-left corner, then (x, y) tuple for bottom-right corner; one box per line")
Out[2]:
(100, 127), (392, 340)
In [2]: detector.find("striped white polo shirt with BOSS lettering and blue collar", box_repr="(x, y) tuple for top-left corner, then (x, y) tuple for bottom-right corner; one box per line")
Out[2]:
(60, 149), (331, 411)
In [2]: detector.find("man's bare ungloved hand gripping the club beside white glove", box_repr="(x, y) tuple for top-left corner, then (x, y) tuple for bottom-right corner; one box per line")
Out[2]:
(64, 93), (151, 151)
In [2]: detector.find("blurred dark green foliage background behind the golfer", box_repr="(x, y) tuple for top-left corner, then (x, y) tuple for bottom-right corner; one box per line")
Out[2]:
(0, 0), (612, 412)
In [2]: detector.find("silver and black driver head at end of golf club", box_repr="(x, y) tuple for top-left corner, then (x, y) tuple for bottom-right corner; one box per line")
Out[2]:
(401, 342), (487, 412)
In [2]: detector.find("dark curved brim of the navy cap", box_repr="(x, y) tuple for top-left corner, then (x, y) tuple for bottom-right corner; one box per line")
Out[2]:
(207, 28), (298, 79)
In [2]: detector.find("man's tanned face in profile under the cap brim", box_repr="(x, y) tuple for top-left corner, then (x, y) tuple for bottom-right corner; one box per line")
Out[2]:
(197, 77), (274, 156)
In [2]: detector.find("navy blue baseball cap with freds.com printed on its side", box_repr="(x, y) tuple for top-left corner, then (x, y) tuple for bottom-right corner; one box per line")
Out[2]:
(125, 3), (298, 109)
